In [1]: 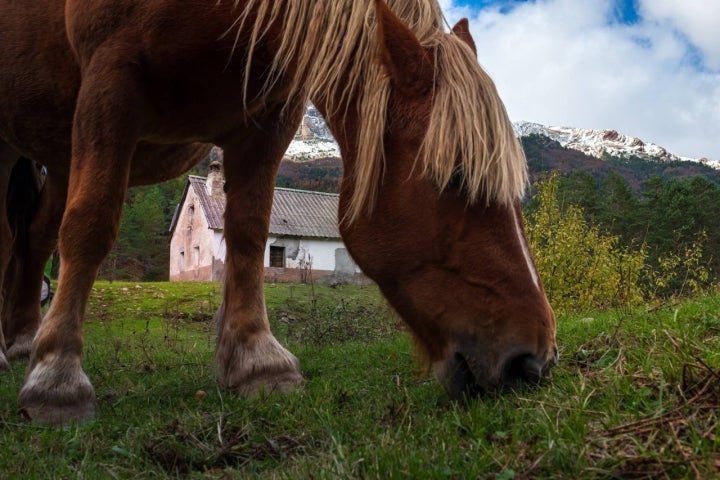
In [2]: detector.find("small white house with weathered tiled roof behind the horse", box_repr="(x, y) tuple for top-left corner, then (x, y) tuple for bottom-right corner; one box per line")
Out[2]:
(170, 162), (368, 283)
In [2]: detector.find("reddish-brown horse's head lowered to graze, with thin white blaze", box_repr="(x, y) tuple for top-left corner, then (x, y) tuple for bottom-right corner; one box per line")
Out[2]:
(340, 2), (557, 398)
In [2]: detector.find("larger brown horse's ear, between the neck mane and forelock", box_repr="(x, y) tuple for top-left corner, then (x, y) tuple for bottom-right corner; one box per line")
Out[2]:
(375, 0), (434, 94)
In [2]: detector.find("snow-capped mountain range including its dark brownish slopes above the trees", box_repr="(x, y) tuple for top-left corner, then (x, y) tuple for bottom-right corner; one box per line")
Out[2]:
(278, 105), (720, 193)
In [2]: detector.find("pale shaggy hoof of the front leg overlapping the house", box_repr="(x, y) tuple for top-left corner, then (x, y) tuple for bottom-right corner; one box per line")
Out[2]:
(218, 334), (305, 396)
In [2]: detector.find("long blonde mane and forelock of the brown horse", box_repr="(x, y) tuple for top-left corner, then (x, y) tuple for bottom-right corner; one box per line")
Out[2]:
(232, 0), (527, 222)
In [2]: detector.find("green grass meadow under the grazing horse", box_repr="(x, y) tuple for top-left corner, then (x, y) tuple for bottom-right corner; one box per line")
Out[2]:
(0, 282), (720, 479)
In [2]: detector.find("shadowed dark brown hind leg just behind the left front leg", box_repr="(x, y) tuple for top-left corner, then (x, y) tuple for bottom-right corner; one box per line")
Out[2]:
(4, 174), (67, 359)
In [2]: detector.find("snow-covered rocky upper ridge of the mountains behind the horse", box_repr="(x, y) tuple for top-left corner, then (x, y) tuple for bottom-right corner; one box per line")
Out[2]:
(285, 104), (720, 169)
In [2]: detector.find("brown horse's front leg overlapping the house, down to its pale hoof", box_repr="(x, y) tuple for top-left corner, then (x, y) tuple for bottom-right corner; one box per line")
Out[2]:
(217, 106), (303, 395)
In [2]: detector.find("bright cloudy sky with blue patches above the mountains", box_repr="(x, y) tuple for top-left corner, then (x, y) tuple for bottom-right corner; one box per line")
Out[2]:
(439, 0), (720, 160)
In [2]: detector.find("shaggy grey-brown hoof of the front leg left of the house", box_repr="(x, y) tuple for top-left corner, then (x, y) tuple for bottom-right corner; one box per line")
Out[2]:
(18, 362), (95, 425)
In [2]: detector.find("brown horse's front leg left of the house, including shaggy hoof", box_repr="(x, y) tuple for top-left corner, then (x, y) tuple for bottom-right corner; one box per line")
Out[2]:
(18, 52), (143, 423)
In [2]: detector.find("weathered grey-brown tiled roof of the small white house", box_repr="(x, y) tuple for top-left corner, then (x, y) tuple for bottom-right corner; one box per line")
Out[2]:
(170, 175), (340, 238)
